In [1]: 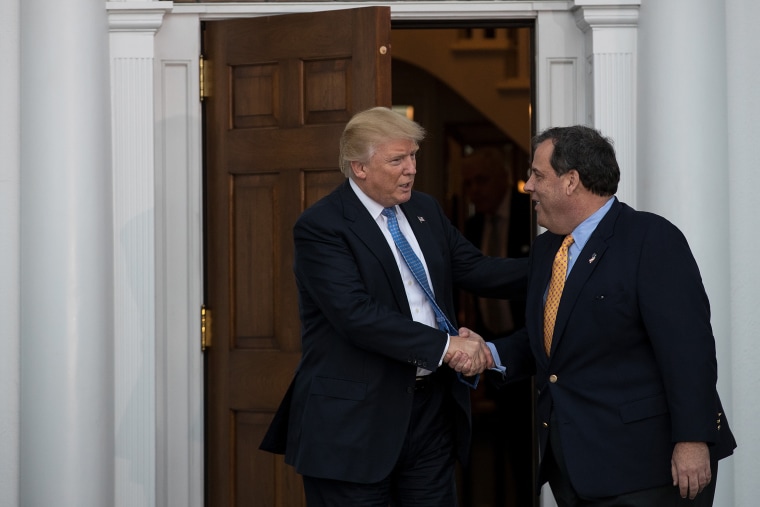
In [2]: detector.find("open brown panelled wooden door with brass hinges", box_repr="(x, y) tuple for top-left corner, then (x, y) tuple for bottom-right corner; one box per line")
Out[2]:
(203, 7), (391, 507)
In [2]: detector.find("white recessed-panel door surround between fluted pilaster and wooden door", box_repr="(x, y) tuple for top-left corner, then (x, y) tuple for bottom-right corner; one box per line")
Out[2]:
(155, 11), (203, 507)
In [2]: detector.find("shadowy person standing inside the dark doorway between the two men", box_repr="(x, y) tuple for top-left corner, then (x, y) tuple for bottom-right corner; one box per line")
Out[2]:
(461, 143), (536, 507)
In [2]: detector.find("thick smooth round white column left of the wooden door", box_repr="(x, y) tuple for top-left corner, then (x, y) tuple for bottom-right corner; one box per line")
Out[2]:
(19, 0), (114, 507)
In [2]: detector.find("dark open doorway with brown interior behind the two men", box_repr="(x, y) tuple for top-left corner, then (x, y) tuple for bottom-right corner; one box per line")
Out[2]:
(391, 25), (538, 507)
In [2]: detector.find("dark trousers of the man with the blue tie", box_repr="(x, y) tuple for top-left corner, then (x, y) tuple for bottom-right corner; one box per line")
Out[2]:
(303, 374), (456, 507)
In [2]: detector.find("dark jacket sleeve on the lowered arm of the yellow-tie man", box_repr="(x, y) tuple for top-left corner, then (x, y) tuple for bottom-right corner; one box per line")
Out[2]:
(638, 219), (718, 443)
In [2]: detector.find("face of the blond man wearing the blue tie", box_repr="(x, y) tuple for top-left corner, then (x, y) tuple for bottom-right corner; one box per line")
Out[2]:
(351, 139), (419, 208)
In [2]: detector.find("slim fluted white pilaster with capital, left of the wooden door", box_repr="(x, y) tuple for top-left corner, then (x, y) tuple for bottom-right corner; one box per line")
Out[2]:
(107, 2), (171, 507)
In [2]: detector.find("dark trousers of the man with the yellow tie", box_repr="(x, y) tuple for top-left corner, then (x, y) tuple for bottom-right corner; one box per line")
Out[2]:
(544, 416), (718, 507)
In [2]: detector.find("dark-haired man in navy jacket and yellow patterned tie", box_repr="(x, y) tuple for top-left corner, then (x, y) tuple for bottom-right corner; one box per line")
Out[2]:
(476, 126), (736, 507)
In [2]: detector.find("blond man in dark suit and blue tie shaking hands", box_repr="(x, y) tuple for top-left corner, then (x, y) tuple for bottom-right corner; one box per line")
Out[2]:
(261, 108), (527, 507)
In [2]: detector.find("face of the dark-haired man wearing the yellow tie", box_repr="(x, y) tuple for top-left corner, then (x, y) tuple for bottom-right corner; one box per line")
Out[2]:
(525, 139), (572, 234)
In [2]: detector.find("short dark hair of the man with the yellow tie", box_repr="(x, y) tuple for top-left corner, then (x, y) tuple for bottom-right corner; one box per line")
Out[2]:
(532, 125), (620, 196)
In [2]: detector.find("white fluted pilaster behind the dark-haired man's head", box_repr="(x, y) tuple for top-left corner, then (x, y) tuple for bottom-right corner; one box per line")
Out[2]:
(574, 0), (641, 206)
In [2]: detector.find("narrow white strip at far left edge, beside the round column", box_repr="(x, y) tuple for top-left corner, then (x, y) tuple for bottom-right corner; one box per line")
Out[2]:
(0, 0), (21, 506)
